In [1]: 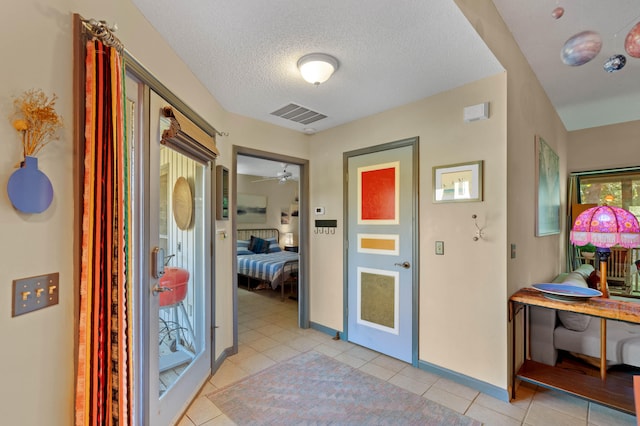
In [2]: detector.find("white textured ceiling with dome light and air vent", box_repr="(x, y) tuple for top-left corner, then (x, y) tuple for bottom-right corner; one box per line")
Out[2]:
(133, 0), (503, 131)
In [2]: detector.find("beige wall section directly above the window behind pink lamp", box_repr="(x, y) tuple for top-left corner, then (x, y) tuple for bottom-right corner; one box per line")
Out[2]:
(567, 120), (640, 172)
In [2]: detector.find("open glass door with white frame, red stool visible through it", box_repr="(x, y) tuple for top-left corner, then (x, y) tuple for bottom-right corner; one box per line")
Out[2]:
(149, 92), (212, 424)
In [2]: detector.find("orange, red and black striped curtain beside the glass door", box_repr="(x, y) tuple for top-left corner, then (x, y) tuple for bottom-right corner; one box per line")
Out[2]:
(76, 40), (133, 425)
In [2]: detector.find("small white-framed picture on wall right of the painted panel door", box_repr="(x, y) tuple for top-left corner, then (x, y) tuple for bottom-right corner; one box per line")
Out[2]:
(433, 160), (483, 203)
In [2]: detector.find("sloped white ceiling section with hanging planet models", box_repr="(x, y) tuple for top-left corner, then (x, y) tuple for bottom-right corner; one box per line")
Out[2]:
(493, 0), (640, 130)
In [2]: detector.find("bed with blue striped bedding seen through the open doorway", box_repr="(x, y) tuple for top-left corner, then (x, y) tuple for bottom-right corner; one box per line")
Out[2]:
(237, 228), (298, 301)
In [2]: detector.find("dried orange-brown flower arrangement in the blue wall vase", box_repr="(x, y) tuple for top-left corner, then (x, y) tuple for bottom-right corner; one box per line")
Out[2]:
(12, 89), (62, 157)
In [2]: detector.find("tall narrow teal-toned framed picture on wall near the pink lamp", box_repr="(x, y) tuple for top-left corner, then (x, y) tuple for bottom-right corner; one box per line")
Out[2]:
(535, 135), (560, 237)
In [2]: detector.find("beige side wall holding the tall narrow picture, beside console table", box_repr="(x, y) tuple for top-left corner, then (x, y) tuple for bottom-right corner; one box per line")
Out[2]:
(456, 0), (568, 294)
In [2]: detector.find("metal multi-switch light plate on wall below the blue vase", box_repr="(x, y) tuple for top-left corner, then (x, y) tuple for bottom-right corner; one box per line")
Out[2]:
(11, 272), (60, 317)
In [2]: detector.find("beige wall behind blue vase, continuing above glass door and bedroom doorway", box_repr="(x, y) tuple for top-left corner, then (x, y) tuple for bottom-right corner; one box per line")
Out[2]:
(0, 0), (308, 426)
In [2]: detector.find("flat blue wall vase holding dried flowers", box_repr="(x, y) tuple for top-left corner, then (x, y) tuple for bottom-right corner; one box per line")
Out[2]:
(7, 157), (53, 213)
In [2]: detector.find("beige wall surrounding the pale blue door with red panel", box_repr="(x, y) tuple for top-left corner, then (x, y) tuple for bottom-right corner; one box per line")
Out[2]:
(310, 74), (507, 388)
